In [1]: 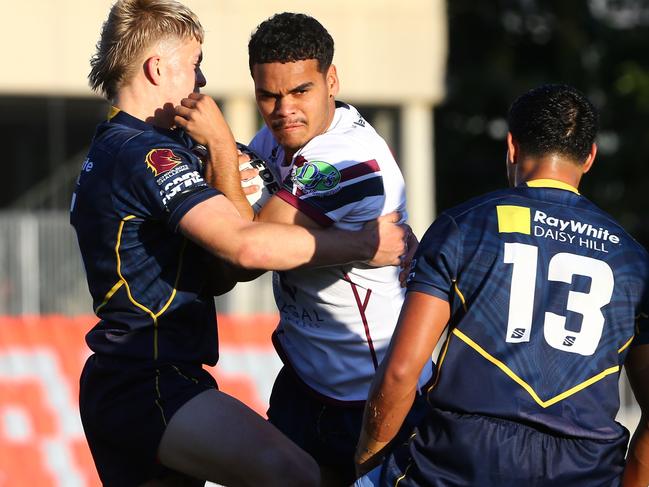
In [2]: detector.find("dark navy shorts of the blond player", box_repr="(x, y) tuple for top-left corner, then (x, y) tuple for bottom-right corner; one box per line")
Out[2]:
(79, 355), (216, 487)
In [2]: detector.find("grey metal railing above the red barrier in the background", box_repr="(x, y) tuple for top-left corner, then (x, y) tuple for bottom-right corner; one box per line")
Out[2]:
(0, 210), (275, 315)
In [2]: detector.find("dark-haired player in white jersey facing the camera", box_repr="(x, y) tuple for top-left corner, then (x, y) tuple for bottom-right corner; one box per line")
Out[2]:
(249, 13), (432, 485)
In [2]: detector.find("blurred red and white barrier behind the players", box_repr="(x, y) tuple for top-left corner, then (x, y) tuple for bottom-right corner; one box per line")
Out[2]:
(0, 314), (280, 487)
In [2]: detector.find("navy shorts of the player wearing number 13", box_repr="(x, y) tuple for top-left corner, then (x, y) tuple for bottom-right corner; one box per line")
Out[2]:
(380, 408), (628, 487)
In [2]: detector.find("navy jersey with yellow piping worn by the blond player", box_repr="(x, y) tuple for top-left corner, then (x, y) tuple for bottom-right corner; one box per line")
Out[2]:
(70, 108), (219, 365)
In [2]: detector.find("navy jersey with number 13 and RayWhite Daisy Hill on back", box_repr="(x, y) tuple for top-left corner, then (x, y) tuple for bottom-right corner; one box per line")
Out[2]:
(408, 180), (649, 439)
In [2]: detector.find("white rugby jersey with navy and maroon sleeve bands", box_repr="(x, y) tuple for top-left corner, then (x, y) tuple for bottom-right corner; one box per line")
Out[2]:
(250, 102), (432, 401)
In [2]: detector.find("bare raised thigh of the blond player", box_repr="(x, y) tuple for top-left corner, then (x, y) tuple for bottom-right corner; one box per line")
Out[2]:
(158, 390), (320, 487)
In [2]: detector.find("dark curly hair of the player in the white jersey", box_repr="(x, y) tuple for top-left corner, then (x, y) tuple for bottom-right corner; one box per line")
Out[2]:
(248, 12), (334, 73)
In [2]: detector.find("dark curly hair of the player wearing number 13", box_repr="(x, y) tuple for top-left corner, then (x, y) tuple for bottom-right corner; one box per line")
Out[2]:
(508, 84), (599, 164)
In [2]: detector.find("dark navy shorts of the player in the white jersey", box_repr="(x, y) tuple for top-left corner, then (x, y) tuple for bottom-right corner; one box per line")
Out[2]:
(268, 367), (428, 485)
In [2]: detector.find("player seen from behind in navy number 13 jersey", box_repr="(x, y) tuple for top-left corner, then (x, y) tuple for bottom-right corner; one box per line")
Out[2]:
(357, 85), (649, 487)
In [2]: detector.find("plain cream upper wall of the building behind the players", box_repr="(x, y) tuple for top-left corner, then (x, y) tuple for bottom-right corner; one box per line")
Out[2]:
(0, 0), (446, 105)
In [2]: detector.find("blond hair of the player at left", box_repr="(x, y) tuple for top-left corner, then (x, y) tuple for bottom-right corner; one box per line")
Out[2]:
(88, 0), (204, 100)
